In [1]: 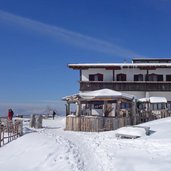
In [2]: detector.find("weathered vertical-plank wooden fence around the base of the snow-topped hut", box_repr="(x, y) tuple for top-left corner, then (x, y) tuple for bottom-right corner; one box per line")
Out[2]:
(65, 110), (170, 132)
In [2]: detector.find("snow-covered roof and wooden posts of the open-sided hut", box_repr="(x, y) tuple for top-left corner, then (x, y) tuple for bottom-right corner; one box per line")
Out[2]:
(63, 89), (135, 116)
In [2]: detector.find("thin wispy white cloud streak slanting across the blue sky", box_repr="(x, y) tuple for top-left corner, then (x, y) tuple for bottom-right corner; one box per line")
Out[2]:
(0, 10), (141, 58)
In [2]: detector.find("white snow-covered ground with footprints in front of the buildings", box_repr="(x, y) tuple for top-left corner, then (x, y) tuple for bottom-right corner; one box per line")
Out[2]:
(0, 117), (171, 171)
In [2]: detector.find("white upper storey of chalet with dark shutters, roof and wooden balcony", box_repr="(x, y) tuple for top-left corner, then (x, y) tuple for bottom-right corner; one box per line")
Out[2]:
(68, 58), (171, 107)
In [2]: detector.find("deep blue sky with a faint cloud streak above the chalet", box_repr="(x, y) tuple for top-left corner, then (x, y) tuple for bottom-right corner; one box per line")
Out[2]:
(0, 0), (171, 115)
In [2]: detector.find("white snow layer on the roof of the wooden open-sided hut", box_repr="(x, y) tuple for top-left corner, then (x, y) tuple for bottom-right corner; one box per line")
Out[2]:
(79, 89), (134, 99)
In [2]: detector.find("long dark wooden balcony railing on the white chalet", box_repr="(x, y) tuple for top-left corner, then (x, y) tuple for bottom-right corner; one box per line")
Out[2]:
(80, 81), (171, 91)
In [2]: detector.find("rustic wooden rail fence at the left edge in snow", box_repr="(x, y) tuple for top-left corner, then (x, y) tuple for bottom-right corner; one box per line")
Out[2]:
(0, 119), (23, 147)
